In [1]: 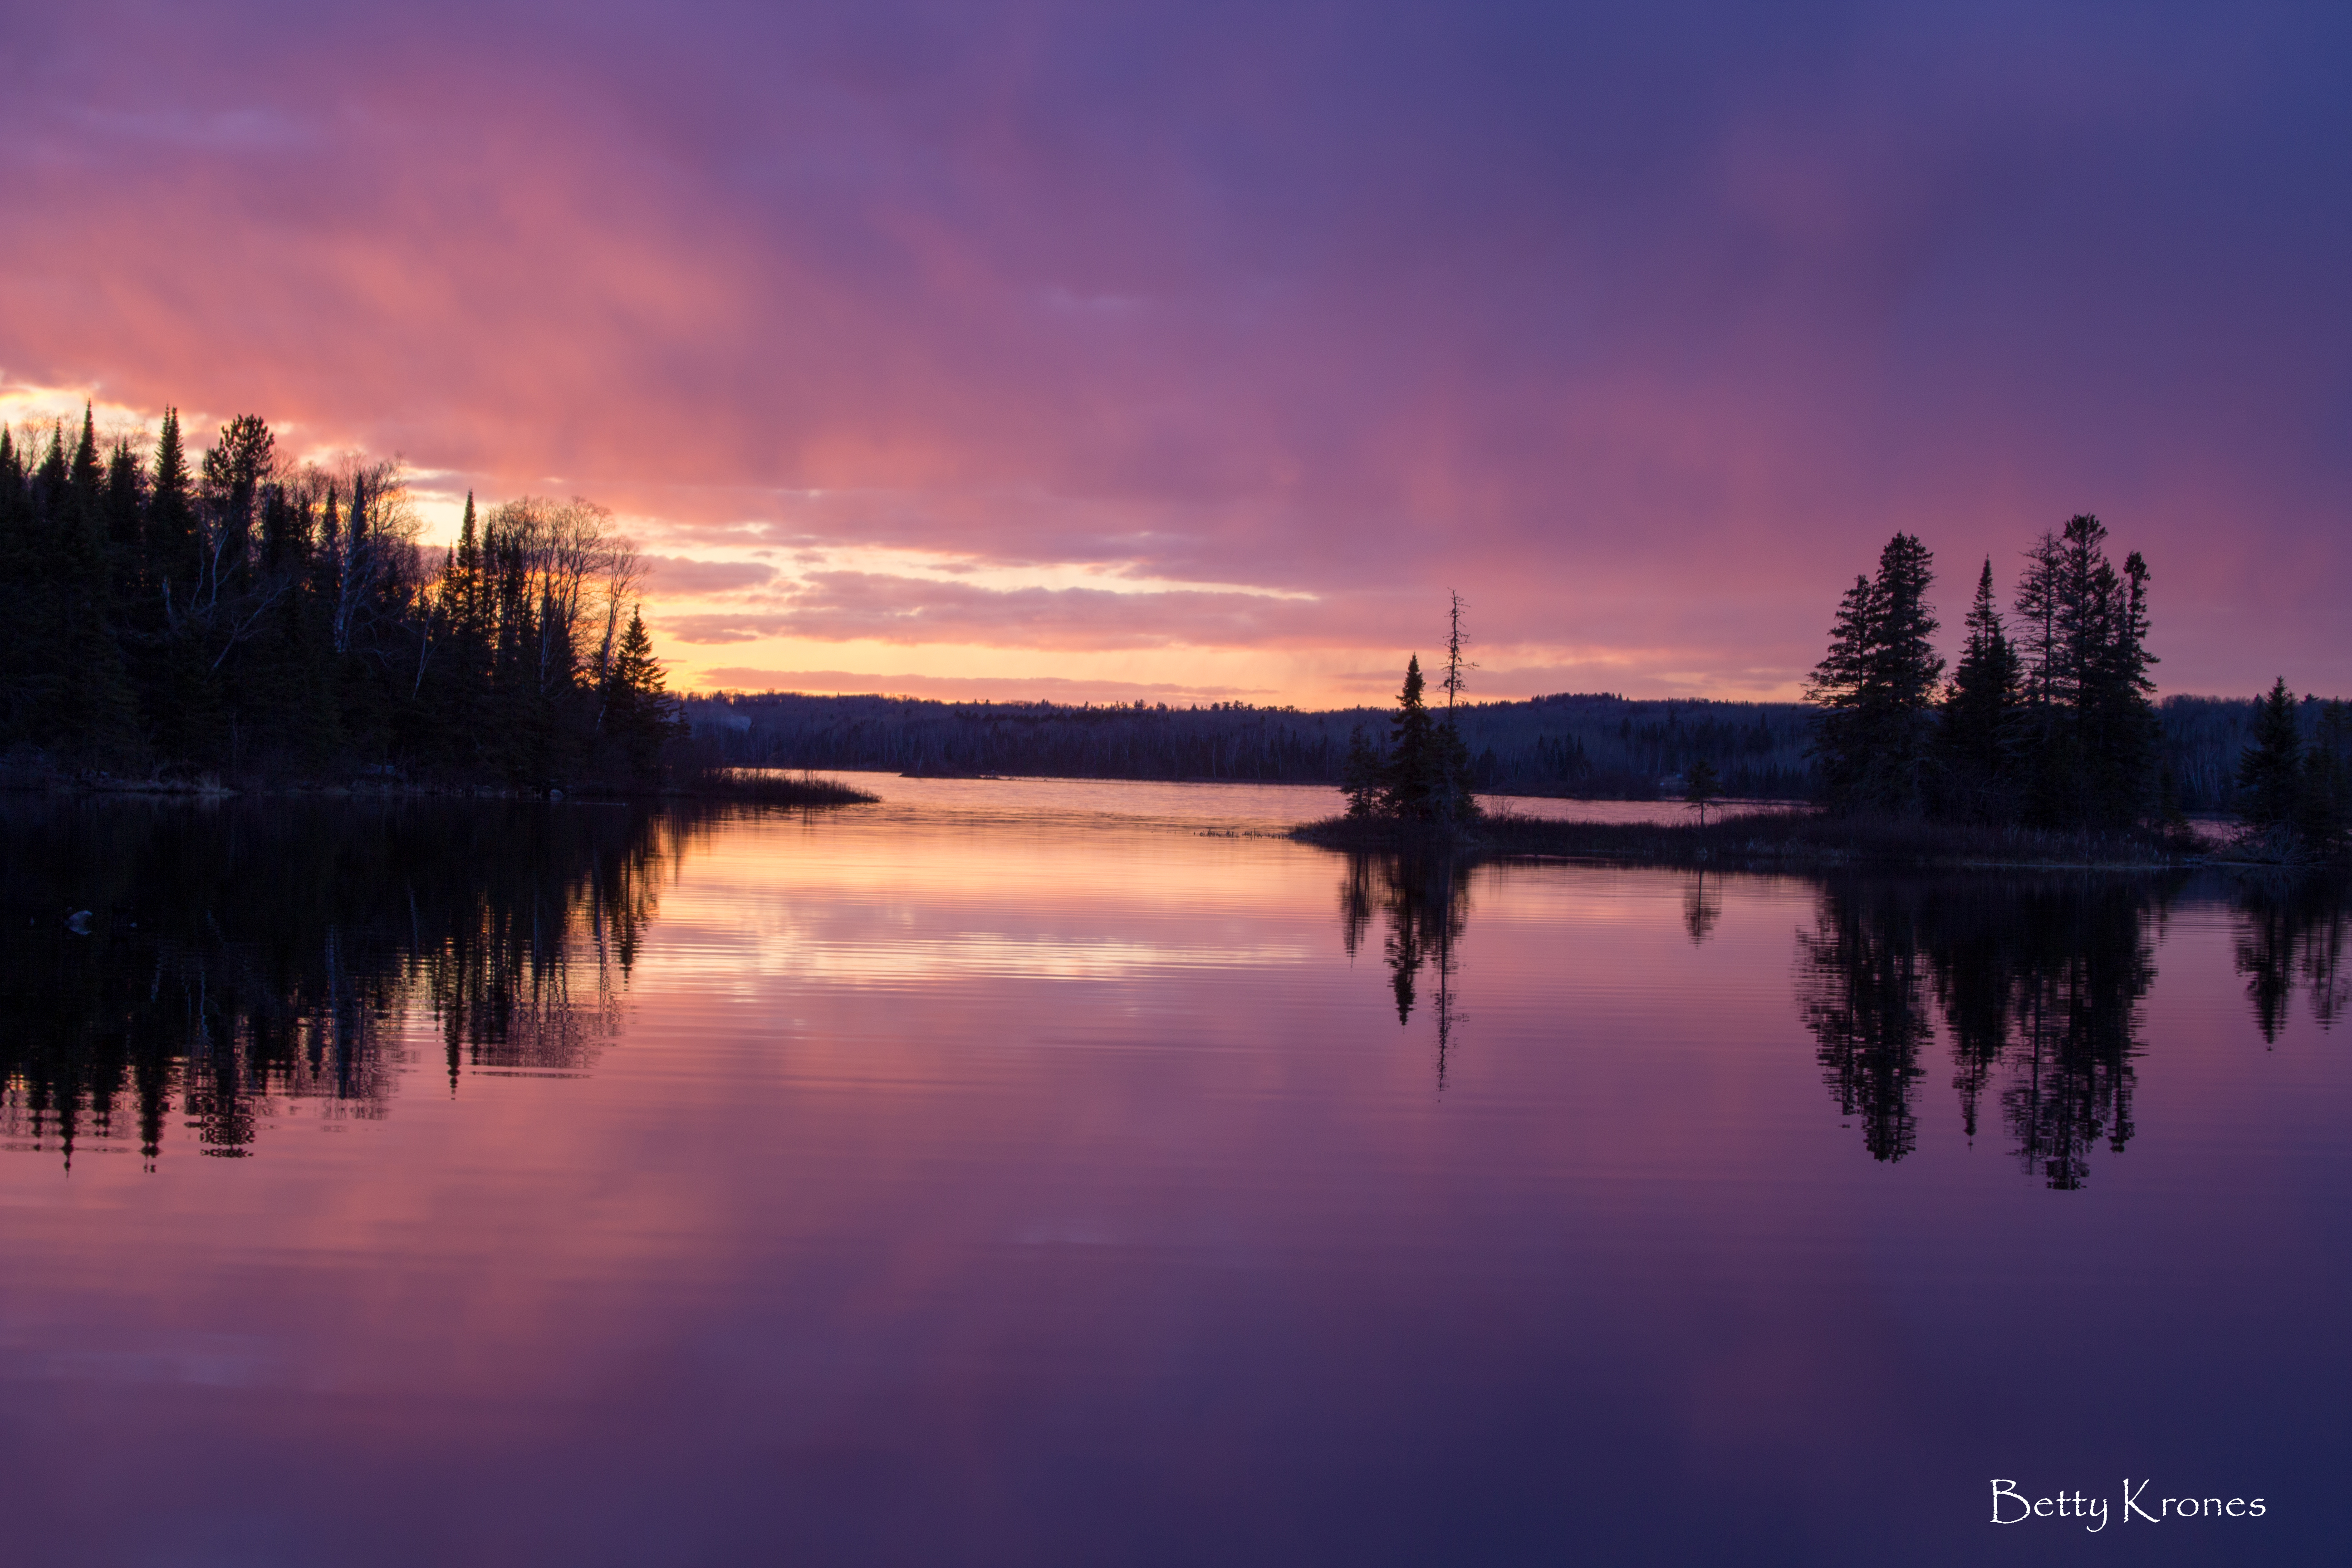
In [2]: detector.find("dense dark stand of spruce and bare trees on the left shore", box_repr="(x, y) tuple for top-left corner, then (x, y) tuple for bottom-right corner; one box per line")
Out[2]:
(0, 409), (680, 788)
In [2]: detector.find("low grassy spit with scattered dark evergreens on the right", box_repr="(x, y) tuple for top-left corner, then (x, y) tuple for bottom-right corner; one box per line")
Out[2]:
(1294, 515), (2352, 874)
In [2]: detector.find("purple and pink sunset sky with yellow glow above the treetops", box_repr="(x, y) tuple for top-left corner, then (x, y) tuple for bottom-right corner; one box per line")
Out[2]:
(0, 0), (2352, 703)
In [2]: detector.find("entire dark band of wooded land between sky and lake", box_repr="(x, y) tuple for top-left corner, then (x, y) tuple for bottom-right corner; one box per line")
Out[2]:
(0, 409), (2352, 863)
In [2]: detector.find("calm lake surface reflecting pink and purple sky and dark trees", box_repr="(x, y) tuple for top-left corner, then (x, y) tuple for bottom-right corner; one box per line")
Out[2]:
(0, 778), (2352, 1566)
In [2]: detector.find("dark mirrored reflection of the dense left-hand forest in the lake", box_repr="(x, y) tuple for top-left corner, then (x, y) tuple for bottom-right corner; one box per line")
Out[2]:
(0, 799), (694, 1166)
